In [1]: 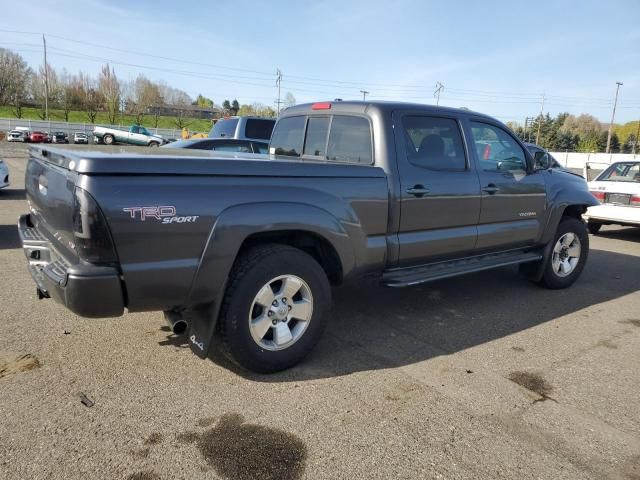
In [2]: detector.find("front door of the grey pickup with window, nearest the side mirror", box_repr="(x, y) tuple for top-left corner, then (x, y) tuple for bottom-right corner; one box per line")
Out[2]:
(467, 119), (546, 253)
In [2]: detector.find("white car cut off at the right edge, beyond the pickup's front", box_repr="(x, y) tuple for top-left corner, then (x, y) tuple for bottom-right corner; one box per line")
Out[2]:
(584, 161), (640, 235)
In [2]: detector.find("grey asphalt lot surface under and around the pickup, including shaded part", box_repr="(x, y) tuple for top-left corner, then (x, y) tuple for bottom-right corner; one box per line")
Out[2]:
(0, 143), (640, 480)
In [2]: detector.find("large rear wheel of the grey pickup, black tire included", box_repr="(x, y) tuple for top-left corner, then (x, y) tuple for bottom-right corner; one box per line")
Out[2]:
(219, 244), (331, 373)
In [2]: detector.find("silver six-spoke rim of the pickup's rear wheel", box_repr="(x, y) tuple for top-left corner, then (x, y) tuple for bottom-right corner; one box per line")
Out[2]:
(249, 275), (313, 351)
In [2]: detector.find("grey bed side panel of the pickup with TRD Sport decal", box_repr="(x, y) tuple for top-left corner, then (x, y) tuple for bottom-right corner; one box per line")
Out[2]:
(80, 169), (388, 311)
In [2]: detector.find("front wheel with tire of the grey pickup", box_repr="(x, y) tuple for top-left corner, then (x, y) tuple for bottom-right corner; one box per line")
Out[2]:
(540, 217), (589, 289)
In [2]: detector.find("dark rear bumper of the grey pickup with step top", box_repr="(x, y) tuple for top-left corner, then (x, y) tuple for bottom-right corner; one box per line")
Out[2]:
(18, 215), (124, 318)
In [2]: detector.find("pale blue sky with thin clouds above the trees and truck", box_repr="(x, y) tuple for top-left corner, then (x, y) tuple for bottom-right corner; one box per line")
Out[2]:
(0, 0), (640, 123)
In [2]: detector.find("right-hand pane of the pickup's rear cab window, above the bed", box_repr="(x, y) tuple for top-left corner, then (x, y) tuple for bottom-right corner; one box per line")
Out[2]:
(327, 115), (373, 164)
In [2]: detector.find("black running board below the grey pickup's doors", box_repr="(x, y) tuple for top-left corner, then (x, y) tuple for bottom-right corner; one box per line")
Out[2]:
(382, 250), (542, 287)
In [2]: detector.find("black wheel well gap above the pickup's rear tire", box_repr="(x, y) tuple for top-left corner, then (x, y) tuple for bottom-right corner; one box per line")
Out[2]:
(239, 230), (342, 285)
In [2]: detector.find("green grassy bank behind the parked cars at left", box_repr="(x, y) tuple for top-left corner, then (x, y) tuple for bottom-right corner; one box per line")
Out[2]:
(0, 105), (211, 132)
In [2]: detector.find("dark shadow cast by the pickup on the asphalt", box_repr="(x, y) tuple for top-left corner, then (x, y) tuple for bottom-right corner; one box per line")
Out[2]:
(165, 246), (640, 382)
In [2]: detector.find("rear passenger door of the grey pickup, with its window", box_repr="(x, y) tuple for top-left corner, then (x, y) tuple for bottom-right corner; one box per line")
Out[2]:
(394, 111), (480, 266)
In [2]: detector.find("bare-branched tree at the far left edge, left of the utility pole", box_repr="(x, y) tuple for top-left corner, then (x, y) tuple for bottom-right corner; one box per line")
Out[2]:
(0, 48), (31, 118)
